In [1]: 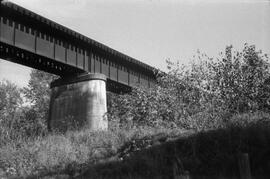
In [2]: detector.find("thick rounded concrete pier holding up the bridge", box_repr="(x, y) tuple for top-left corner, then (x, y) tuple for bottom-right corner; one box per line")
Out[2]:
(48, 74), (108, 132)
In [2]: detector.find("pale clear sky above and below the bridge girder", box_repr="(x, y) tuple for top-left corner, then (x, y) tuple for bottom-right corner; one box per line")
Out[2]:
(0, 0), (270, 86)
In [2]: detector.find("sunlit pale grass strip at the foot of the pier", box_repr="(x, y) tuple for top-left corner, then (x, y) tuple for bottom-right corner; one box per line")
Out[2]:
(0, 128), (186, 177)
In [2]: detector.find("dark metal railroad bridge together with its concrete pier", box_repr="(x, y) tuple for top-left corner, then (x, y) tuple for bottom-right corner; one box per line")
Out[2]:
(0, 1), (155, 130)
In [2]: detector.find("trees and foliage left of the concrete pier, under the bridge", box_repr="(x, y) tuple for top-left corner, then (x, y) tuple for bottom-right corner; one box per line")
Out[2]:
(0, 70), (55, 146)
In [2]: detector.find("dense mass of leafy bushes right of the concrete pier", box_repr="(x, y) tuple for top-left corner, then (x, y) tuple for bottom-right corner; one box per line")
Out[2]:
(109, 44), (270, 130)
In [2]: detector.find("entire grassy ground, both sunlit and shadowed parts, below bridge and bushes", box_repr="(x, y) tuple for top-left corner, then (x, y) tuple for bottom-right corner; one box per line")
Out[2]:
(0, 112), (270, 178)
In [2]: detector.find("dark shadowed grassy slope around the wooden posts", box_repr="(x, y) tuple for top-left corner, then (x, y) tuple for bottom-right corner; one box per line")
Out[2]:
(80, 122), (270, 179)
